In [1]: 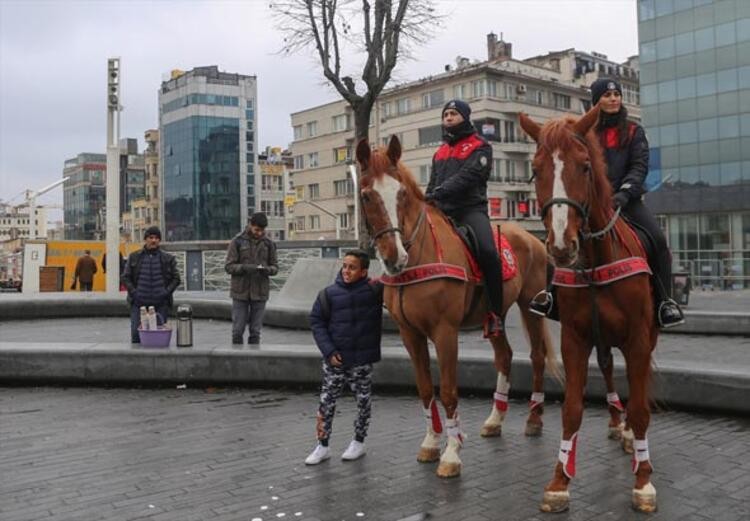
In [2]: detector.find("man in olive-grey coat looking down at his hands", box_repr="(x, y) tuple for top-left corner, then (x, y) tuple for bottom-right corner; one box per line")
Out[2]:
(224, 212), (279, 344)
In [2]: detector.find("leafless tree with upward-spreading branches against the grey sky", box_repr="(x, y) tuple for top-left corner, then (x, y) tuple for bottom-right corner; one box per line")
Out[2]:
(270, 0), (441, 141)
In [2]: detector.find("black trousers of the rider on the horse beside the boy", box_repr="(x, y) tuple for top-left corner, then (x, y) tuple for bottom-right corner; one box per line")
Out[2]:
(448, 209), (503, 315)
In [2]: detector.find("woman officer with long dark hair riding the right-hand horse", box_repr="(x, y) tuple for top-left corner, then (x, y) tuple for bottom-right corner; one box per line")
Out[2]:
(531, 78), (685, 328)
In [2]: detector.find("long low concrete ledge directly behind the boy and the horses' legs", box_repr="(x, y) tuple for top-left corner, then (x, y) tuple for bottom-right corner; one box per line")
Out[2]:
(0, 342), (750, 414)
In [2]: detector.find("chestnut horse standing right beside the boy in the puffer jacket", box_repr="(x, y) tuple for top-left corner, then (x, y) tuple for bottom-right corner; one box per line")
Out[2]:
(357, 136), (559, 477)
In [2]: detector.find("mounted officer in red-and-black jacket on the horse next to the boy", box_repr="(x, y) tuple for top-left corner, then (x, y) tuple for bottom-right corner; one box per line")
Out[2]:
(425, 99), (503, 337)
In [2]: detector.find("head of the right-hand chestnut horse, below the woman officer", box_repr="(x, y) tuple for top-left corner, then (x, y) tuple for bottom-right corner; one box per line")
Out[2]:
(520, 106), (610, 267)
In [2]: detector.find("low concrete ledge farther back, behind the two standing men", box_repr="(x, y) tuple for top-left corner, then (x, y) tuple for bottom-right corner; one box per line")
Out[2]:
(0, 294), (750, 336)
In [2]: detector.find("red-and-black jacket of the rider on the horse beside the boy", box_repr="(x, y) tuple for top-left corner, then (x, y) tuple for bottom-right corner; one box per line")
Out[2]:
(425, 132), (492, 213)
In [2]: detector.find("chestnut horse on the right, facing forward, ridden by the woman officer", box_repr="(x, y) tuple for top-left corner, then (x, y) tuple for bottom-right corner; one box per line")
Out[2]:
(520, 107), (658, 512)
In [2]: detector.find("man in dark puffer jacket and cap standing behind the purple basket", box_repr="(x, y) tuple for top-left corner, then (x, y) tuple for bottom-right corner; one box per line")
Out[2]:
(122, 226), (180, 344)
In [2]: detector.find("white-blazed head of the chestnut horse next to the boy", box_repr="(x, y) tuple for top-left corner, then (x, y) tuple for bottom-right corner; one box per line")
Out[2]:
(357, 136), (409, 275)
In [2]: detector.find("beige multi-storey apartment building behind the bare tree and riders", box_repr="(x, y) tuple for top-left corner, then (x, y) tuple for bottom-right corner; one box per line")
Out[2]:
(291, 34), (638, 239)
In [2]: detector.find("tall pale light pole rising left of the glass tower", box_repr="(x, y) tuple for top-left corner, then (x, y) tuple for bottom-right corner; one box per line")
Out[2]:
(105, 58), (122, 295)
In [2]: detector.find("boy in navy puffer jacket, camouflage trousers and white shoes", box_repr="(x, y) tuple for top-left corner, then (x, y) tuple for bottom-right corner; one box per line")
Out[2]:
(305, 250), (383, 465)
